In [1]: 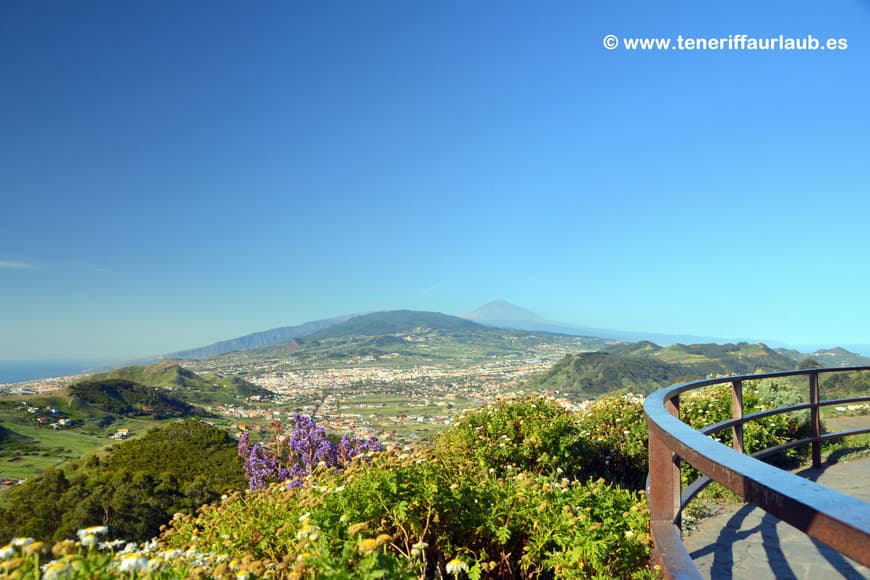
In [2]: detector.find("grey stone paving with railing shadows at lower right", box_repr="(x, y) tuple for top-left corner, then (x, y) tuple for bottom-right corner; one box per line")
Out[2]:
(683, 458), (870, 580)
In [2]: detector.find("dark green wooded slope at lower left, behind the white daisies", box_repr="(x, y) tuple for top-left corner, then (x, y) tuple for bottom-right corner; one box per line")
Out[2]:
(0, 420), (244, 543)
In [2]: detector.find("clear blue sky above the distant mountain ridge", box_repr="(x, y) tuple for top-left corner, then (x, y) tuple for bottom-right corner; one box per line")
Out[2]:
(0, 0), (870, 359)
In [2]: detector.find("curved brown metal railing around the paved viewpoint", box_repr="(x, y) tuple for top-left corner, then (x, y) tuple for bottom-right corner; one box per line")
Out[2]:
(644, 367), (870, 579)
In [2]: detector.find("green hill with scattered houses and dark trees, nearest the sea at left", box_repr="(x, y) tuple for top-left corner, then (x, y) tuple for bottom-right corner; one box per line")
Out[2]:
(0, 361), (262, 479)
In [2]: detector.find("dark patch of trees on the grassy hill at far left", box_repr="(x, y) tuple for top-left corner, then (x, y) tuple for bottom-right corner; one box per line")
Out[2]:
(69, 379), (198, 419)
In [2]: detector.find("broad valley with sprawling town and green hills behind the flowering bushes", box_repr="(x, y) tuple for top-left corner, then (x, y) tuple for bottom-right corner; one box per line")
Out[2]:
(0, 311), (870, 482)
